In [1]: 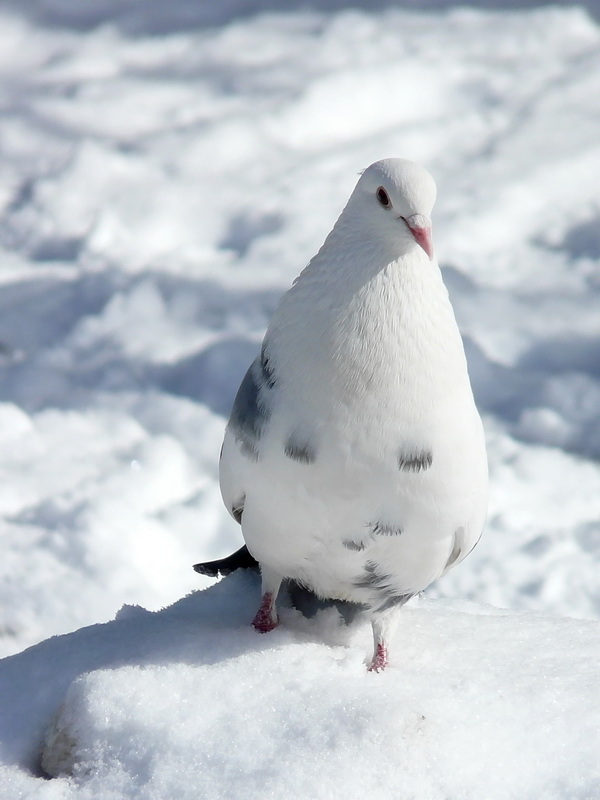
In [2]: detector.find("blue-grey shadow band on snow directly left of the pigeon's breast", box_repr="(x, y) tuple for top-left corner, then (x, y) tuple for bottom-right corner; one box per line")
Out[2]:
(0, 270), (281, 416)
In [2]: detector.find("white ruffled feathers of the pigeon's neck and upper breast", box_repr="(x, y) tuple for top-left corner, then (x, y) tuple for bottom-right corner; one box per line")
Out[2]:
(265, 209), (468, 416)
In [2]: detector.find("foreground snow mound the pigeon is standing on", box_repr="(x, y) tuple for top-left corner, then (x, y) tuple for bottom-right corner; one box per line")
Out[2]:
(0, 573), (600, 800)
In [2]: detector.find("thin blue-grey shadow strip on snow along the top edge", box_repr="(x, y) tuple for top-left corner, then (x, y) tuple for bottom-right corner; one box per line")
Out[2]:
(0, 0), (600, 36)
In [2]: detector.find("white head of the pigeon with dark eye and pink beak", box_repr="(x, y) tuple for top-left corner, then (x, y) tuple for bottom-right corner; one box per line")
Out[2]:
(348, 158), (436, 259)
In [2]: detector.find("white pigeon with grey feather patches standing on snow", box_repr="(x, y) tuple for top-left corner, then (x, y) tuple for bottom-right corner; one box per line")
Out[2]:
(220, 158), (487, 671)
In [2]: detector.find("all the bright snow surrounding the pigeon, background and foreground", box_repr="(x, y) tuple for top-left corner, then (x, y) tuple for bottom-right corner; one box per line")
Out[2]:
(0, 0), (600, 800)
